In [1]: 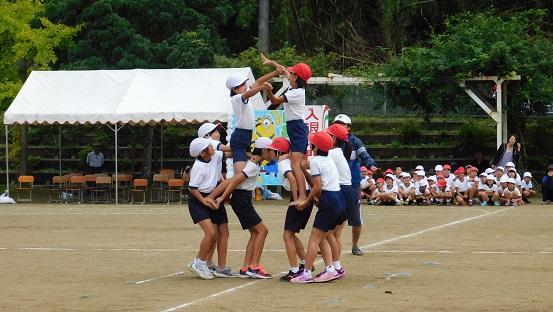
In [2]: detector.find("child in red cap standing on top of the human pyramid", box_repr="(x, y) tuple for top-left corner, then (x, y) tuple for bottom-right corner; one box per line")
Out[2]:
(261, 54), (311, 201)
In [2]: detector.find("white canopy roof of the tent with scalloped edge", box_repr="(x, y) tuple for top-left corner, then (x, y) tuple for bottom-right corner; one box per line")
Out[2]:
(4, 67), (265, 125)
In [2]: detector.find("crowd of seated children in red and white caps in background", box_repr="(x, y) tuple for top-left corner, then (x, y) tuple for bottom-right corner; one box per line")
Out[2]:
(361, 162), (536, 206)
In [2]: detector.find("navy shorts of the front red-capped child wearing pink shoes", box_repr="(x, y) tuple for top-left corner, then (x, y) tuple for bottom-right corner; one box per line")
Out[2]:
(313, 191), (345, 232)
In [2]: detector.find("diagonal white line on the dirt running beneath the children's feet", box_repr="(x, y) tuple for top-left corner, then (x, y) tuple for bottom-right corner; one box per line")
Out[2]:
(157, 207), (513, 312)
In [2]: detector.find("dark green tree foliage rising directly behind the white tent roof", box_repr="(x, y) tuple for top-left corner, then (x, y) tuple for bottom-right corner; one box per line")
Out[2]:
(45, 0), (235, 70)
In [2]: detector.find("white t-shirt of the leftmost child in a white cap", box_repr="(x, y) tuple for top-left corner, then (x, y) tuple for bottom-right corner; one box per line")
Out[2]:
(188, 151), (225, 193)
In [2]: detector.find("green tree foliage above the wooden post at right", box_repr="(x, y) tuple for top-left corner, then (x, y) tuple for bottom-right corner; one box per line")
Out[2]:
(371, 10), (553, 123)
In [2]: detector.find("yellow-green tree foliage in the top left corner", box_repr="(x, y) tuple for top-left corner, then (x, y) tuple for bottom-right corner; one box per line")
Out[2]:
(0, 0), (81, 110)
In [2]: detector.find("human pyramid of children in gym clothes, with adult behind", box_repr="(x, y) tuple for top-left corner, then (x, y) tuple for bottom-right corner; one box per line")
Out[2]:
(188, 54), (375, 283)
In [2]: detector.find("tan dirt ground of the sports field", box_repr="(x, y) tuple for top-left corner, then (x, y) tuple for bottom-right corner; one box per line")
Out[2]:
(0, 199), (553, 311)
